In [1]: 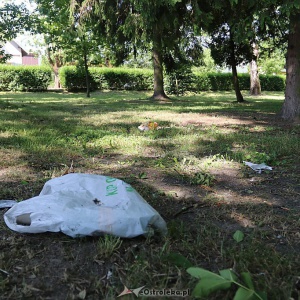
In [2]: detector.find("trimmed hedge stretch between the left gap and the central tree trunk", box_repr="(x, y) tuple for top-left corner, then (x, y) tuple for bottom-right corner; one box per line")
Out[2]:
(59, 66), (153, 91)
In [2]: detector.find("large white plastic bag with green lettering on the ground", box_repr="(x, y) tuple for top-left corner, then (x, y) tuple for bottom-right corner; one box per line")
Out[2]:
(4, 173), (167, 238)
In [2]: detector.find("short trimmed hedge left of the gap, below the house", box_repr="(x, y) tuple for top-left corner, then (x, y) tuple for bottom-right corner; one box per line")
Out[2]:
(0, 65), (51, 91)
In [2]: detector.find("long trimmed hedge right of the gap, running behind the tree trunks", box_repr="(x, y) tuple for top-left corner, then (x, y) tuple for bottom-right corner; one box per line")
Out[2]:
(59, 66), (285, 94)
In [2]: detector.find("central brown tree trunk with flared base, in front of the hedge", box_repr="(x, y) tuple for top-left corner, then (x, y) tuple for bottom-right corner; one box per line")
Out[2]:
(151, 30), (169, 100)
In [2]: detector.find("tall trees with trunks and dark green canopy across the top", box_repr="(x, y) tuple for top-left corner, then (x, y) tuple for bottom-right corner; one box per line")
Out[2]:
(0, 0), (300, 121)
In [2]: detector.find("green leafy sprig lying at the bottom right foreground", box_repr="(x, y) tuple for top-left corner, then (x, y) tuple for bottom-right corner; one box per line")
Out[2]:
(187, 267), (267, 300)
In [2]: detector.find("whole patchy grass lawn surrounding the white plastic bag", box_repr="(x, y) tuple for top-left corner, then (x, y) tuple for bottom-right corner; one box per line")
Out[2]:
(0, 91), (300, 299)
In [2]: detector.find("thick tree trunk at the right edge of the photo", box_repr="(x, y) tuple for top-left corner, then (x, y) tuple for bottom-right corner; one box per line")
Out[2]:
(281, 13), (300, 121)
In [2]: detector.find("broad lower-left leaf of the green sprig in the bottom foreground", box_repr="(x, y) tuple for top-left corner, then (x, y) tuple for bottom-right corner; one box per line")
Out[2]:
(192, 273), (231, 297)
